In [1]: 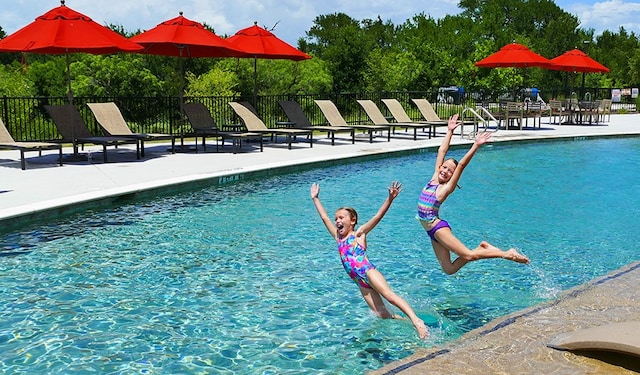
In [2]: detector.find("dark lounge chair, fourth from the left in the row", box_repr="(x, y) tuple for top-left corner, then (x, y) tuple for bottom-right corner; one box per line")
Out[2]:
(182, 102), (263, 154)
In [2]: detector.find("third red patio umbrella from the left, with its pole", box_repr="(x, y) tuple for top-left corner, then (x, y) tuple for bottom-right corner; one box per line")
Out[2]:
(227, 22), (311, 105)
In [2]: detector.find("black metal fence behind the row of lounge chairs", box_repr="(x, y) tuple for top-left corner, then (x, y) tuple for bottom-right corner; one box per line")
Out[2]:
(0, 89), (628, 141)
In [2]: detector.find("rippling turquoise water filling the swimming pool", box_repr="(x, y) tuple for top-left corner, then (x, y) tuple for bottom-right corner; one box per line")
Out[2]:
(0, 139), (640, 374)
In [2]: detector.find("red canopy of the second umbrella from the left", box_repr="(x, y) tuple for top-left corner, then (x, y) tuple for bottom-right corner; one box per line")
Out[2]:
(131, 12), (245, 57)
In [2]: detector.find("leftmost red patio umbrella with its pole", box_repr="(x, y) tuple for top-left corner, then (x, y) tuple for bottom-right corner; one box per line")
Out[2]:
(0, 0), (142, 157)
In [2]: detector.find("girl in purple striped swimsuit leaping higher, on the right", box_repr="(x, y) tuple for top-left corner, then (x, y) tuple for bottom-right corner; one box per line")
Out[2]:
(416, 114), (529, 275)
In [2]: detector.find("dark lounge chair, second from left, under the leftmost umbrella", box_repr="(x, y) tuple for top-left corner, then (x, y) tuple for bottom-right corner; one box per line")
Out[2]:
(44, 104), (140, 163)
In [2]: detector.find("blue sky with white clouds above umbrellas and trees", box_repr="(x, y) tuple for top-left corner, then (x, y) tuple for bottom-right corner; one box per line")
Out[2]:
(0, 0), (640, 46)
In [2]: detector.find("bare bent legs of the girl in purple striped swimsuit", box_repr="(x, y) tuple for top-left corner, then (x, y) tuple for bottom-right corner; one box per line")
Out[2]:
(431, 228), (529, 274)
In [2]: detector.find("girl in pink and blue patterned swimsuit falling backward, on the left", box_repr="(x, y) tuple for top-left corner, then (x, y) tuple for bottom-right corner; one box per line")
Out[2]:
(311, 181), (427, 339)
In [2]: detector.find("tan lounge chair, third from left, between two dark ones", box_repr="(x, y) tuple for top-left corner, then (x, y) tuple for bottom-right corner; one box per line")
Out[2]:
(87, 102), (176, 157)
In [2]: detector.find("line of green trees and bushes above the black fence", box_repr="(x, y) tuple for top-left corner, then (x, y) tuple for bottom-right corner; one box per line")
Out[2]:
(0, 0), (640, 101)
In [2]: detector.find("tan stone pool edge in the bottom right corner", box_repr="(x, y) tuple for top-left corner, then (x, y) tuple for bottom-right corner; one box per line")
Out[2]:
(369, 262), (640, 375)
